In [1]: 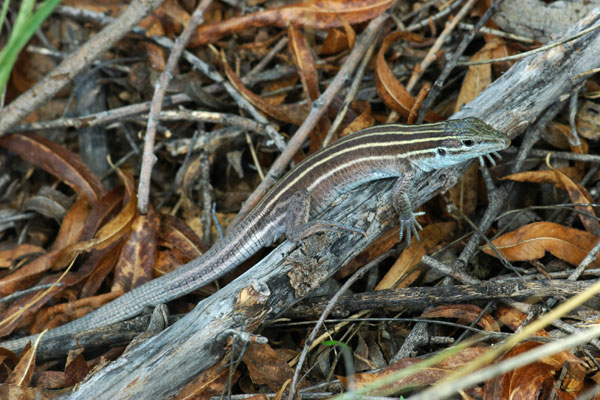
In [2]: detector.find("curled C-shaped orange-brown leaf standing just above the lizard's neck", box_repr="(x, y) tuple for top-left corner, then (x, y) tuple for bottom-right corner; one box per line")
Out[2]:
(375, 31), (442, 122)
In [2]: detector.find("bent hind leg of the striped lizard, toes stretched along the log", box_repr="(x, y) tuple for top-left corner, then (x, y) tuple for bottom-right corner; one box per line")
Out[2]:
(283, 189), (366, 243)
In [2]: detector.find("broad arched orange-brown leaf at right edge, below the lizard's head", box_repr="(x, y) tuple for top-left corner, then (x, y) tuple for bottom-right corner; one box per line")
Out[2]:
(482, 222), (600, 268)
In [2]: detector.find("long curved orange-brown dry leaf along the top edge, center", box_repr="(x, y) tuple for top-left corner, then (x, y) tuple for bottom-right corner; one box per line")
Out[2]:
(189, 0), (393, 47)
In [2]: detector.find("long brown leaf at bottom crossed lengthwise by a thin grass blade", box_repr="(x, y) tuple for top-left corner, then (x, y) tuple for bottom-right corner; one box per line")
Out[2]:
(338, 347), (488, 396)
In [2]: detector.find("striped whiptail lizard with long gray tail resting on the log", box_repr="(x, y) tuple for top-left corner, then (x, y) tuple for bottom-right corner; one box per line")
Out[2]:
(0, 118), (510, 351)
